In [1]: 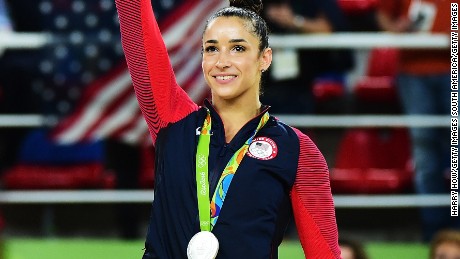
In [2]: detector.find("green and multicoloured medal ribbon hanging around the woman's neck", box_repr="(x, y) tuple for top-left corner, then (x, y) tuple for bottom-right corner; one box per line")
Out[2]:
(196, 110), (270, 231)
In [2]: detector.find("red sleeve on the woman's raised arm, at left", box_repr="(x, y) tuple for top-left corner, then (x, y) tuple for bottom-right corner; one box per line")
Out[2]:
(115, 0), (198, 143)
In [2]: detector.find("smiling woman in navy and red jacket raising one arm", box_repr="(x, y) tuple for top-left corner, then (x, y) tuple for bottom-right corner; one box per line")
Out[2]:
(116, 0), (340, 259)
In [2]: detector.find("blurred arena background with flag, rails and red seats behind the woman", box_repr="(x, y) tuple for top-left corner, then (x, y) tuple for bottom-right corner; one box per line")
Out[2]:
(0, 0), (454, 259)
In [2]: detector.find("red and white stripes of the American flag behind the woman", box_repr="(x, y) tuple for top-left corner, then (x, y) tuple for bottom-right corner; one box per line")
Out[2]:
(53, 0), (225, 144)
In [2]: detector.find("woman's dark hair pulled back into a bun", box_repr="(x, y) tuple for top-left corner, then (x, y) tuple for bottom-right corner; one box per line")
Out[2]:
(205, 0), (268, 51)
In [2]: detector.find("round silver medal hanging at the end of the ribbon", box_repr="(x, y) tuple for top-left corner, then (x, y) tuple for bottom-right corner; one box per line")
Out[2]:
(187, 231), (219, 259)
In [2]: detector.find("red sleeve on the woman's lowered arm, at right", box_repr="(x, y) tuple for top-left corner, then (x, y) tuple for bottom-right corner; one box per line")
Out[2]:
(291, 129), (340, 259)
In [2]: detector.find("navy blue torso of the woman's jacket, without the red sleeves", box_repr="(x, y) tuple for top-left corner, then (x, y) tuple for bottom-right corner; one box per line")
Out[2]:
(151, 103), (299, 258)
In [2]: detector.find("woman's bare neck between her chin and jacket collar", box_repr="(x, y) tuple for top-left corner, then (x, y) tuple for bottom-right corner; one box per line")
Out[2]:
(213, 98), (261, 143)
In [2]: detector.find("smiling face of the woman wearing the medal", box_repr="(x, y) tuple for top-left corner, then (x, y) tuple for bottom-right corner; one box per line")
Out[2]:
(202, 17), (272, 100)
